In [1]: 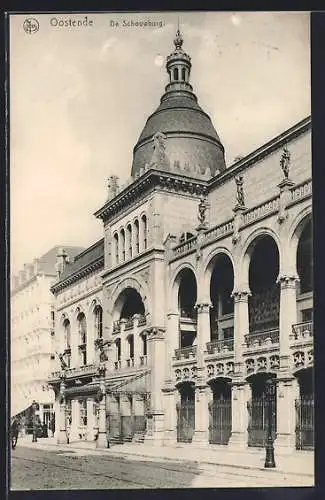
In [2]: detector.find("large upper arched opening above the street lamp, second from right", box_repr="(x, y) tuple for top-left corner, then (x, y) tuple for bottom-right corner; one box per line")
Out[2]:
(248, 235), (280, 343)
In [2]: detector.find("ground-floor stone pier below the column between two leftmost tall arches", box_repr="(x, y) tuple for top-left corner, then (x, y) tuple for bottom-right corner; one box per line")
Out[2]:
(192, 385), (211, 446)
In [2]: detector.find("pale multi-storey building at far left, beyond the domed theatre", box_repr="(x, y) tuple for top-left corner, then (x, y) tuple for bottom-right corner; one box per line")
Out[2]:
(11, 247), (81, 431)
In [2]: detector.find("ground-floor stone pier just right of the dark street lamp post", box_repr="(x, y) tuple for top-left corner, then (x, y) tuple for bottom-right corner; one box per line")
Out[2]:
(274, 374), (299, 454)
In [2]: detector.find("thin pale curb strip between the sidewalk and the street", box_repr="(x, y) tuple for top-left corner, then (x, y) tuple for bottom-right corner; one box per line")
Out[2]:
(16, 442), (314, 478)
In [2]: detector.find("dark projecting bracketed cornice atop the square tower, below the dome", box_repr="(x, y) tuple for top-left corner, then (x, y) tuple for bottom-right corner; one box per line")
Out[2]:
(94, 168), (207, 221)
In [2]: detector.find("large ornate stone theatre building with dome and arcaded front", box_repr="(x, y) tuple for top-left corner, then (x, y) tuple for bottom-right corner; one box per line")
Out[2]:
(49, 32), (314, 453)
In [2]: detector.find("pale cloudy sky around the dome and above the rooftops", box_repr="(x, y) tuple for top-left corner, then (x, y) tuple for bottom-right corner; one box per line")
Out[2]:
(9, 12), (310, 274)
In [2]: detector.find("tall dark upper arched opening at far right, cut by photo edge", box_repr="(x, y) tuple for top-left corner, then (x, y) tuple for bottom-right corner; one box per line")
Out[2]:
(297, 220), (313, 322)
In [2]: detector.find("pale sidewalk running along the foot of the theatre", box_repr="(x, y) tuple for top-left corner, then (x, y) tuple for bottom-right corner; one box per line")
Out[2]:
(18, 436), (314, 477)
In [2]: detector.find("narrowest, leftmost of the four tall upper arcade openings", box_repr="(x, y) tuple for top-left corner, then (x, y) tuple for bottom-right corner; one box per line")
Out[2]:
(178, 268), (197, 349)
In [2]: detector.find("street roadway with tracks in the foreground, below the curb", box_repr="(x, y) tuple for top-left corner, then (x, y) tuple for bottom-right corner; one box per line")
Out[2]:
(11, 440), (314, 490)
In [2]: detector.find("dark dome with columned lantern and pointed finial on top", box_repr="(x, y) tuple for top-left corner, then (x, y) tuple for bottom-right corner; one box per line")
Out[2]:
(132, 32), (225, 177)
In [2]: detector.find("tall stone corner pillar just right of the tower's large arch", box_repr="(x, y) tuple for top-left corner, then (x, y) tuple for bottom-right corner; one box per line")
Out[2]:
(145, 327), (165, 446)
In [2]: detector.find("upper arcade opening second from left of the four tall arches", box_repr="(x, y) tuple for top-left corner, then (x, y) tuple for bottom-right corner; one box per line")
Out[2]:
(210, 254), (234, 344)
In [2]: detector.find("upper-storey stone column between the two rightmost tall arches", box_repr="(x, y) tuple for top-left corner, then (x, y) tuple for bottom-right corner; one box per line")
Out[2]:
(278, 275), (299, 372)
